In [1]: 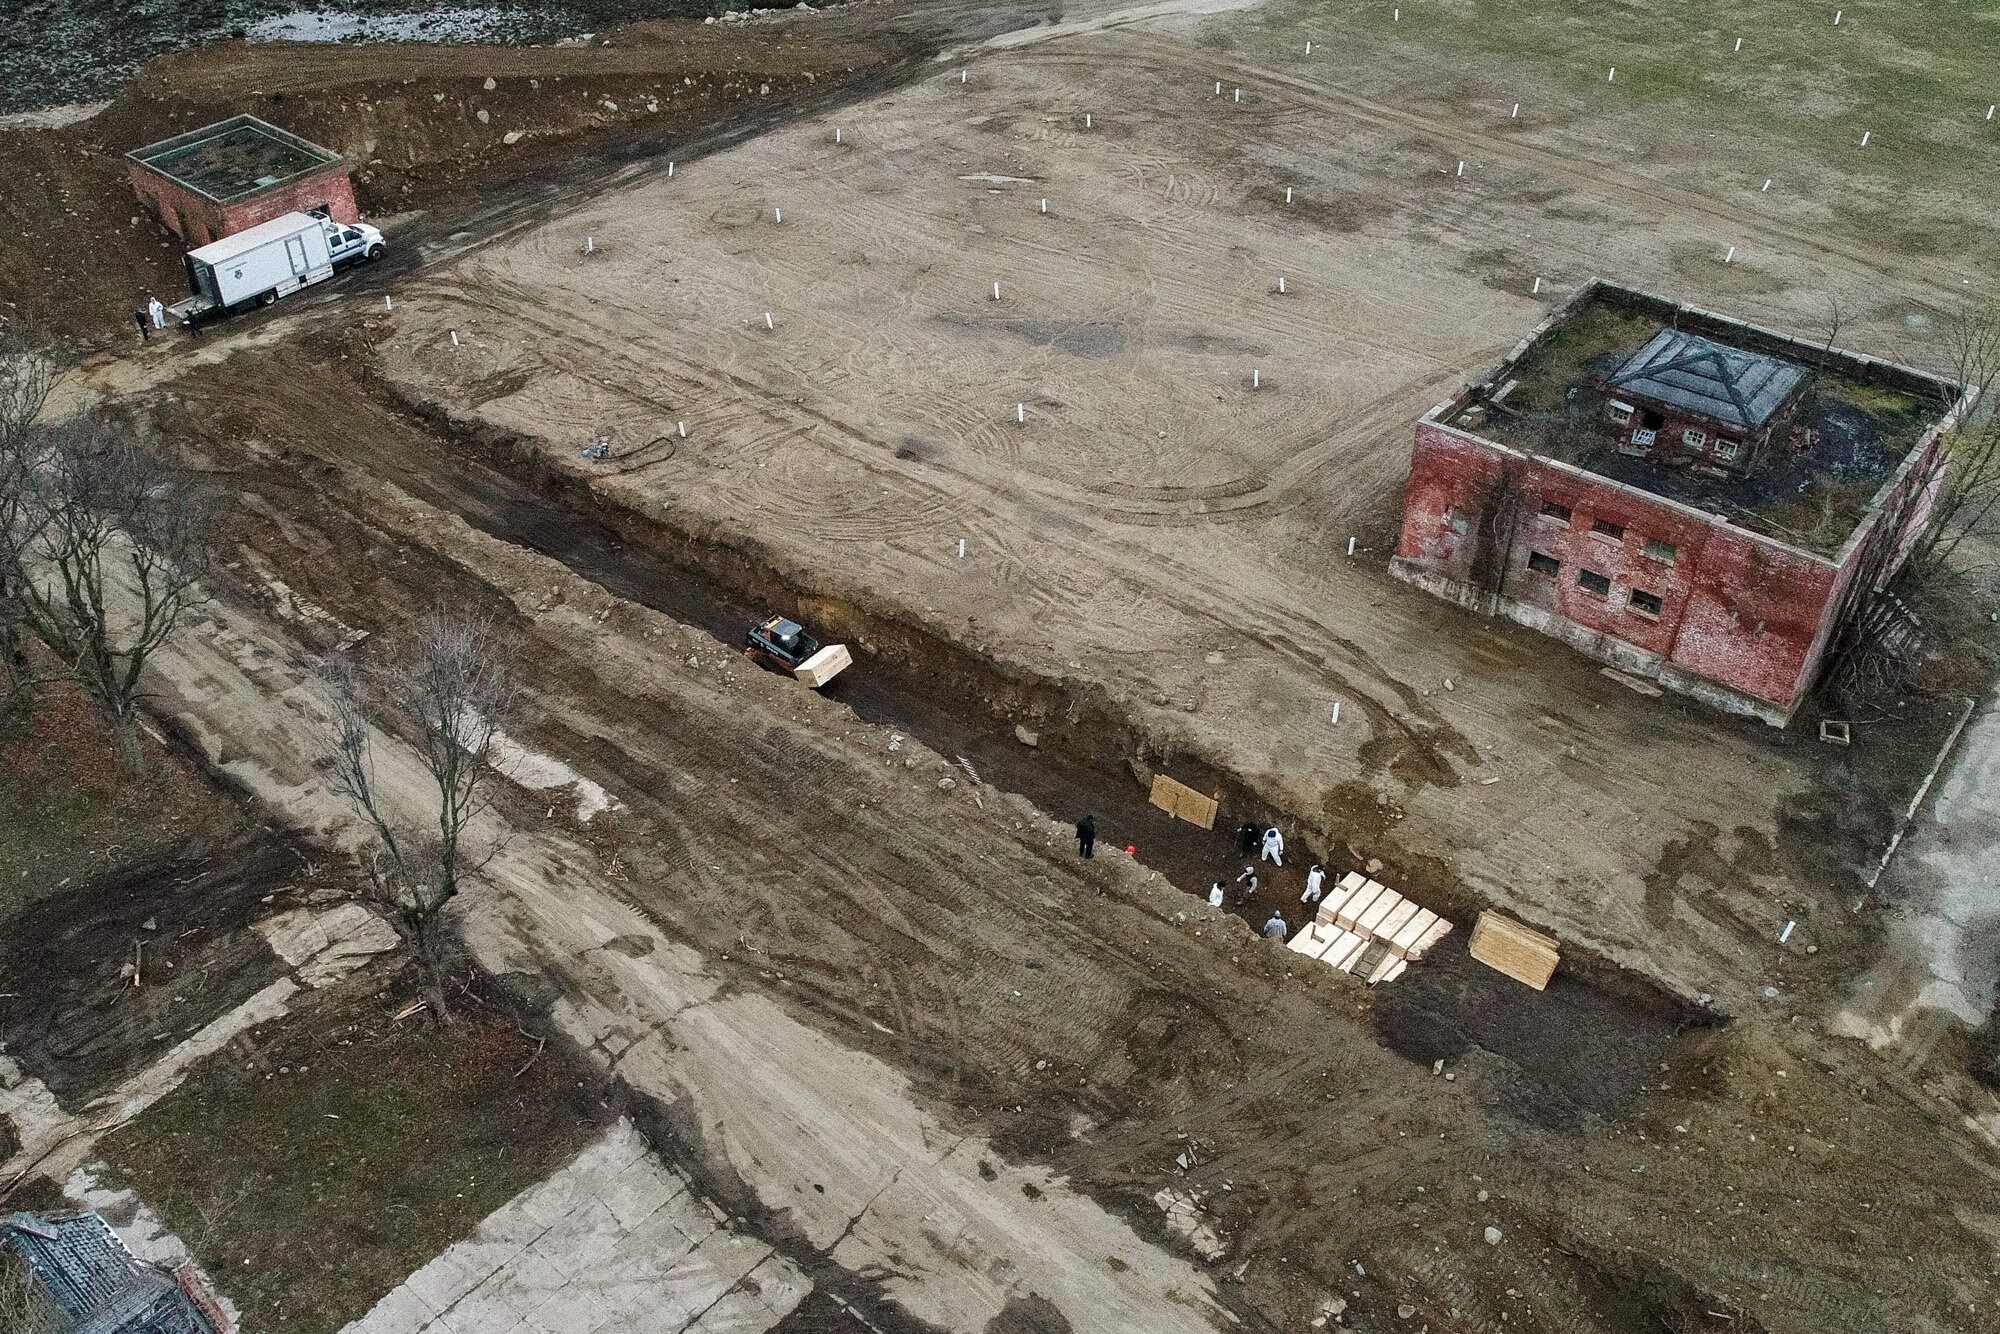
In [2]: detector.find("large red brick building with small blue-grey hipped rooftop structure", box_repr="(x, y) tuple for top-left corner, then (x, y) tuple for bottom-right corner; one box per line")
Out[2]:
(1390, 282), (1970, 726)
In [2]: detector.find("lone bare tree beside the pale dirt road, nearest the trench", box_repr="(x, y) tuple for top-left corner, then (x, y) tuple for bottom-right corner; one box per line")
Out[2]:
(322, 606), (518, 1008)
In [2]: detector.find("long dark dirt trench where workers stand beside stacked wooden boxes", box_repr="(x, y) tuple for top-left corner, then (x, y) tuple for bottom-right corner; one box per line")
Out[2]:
(282, 350), (1718, 1130)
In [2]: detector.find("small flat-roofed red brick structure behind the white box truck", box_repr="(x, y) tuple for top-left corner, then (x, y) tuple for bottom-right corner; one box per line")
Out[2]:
(126, 116), (360, 248)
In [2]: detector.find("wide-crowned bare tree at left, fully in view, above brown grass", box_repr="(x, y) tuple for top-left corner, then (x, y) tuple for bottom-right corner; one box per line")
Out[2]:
(16, 418), (212, 770)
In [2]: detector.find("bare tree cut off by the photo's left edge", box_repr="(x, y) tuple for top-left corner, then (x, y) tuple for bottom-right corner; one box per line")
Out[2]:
(0, 324), (62, 708)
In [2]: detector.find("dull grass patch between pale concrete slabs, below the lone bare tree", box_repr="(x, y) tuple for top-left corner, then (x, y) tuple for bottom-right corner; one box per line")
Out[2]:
(104, 970), (610, 1334)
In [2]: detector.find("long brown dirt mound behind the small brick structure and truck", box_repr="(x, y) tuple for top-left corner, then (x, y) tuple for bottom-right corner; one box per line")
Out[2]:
(0, 22), (902, 346)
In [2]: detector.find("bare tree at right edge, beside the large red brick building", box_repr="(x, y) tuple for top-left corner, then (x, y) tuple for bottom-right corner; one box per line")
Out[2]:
(1904, 300), (2000, 584)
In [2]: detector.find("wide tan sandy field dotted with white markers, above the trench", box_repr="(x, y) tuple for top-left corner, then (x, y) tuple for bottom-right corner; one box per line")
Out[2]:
(348, 6), (1984, 1010)
